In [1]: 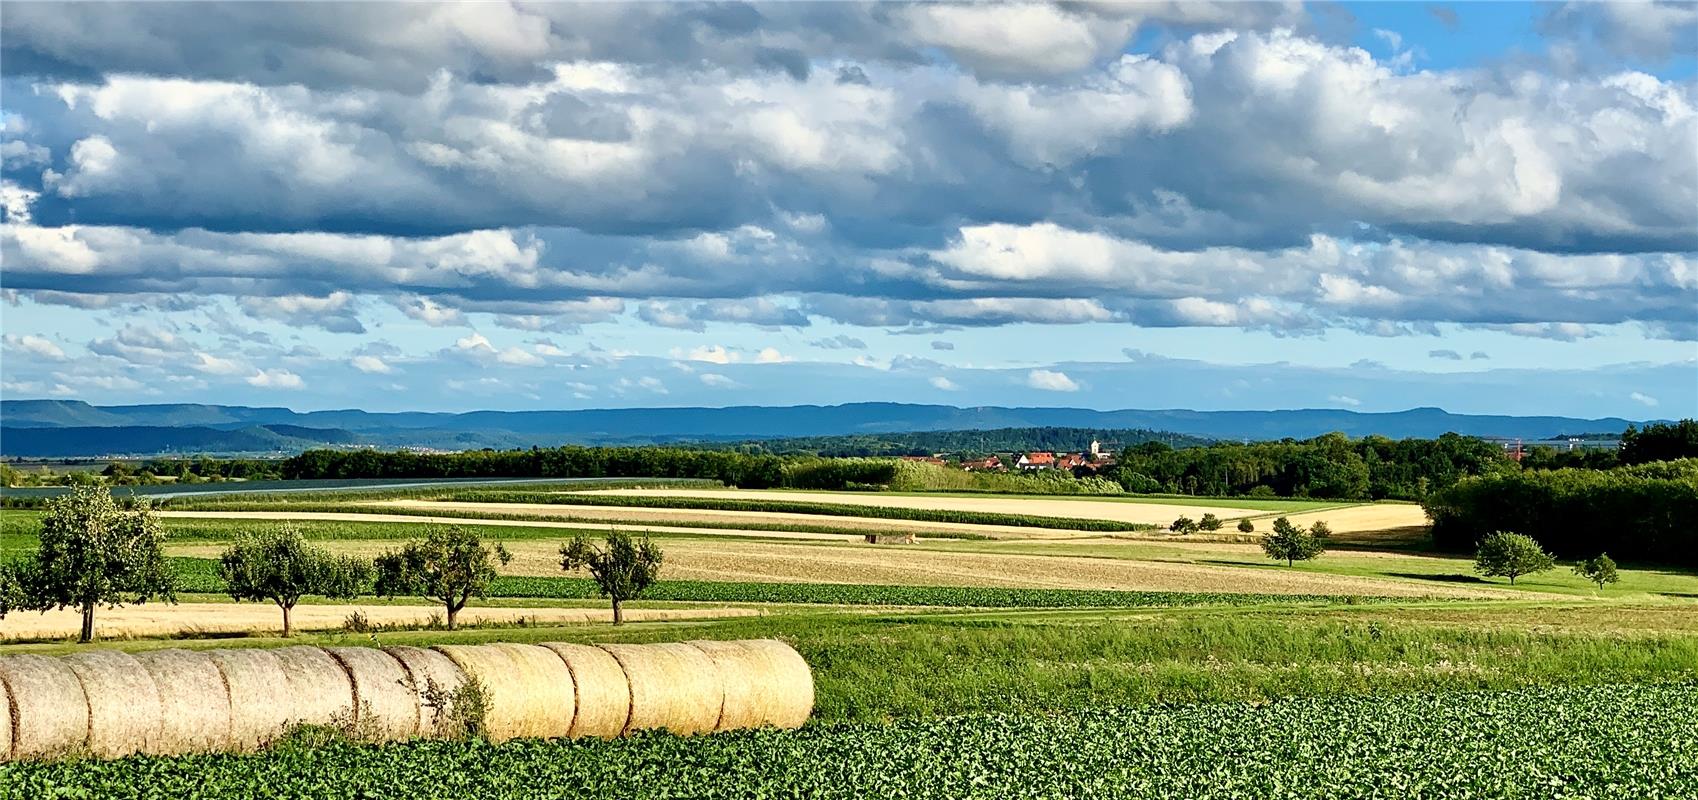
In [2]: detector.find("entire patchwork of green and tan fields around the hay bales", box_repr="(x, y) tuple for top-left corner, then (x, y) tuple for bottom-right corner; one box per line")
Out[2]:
(0, 493), (1698, 798)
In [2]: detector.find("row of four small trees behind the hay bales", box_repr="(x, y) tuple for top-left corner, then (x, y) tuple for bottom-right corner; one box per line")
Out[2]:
(0, 487), (662, 642)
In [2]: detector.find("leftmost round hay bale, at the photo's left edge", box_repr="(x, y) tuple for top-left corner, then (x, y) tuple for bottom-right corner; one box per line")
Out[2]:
(0, 656), (88, 759)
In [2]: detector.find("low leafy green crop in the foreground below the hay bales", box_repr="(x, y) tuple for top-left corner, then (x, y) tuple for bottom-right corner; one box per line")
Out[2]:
(0, 683), (1698, 798)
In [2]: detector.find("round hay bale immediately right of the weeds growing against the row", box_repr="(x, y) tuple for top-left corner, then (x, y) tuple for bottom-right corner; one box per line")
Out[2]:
(436, 644), (577, 742)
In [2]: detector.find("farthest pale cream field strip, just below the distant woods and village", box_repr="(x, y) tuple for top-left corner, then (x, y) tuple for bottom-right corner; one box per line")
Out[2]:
(572, 489), (1267, 525)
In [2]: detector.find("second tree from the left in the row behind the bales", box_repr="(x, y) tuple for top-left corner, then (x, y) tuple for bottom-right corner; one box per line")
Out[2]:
(219, 525), (372, 637)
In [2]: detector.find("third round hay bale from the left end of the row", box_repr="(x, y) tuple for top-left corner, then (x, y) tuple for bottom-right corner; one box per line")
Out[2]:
(136, 651), (229, 756)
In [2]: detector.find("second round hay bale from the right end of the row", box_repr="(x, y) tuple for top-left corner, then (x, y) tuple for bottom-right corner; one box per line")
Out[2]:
(599, 642), (725, 734)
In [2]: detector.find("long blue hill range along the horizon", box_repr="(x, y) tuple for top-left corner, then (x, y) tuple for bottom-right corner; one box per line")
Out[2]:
(0, 399), (1637, 457)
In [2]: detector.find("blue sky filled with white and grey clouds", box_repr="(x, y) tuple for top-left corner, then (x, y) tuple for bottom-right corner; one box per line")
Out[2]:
(0, 2), (1698, 420)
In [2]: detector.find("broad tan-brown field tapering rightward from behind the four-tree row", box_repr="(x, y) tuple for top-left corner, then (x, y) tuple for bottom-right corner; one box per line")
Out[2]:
(465, 540), (1527, 598)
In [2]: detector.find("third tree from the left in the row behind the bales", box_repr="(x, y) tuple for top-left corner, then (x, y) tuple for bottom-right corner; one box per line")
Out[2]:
(375, 525), (513, 630)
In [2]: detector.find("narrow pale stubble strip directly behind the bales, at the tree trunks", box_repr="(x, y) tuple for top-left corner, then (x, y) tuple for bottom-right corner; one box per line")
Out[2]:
(0, 604), (762, 640)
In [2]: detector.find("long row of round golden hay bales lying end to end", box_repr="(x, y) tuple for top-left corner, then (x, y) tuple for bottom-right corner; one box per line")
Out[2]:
(0, 640), (813, 759)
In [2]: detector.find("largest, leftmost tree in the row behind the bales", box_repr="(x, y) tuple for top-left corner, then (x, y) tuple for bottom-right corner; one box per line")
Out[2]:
(22, 486), (177, 642)
